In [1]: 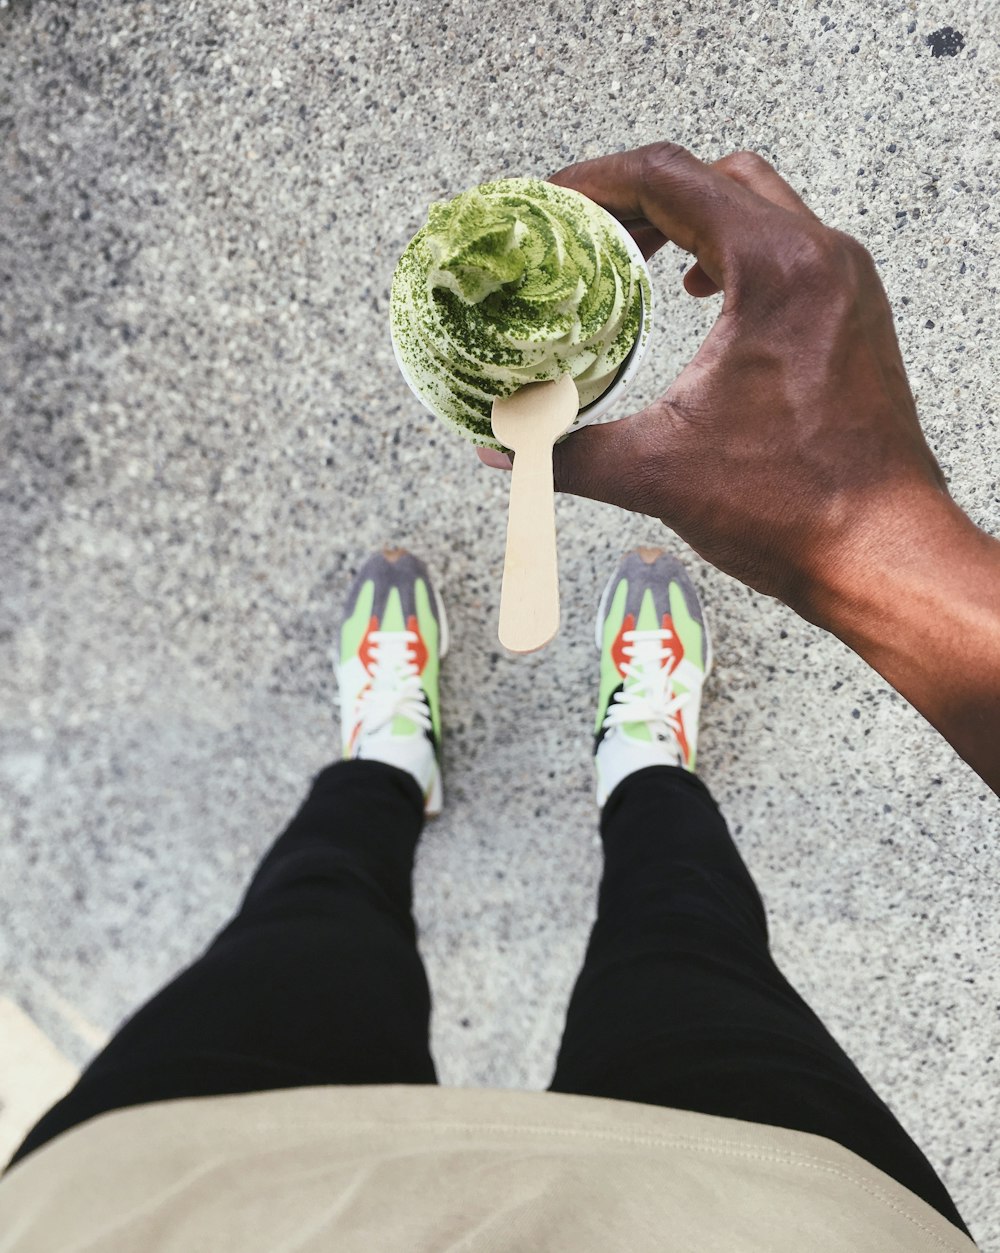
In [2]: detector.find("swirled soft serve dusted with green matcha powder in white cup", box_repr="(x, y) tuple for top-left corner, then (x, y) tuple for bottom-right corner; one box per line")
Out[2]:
(390, 178), (649, 447)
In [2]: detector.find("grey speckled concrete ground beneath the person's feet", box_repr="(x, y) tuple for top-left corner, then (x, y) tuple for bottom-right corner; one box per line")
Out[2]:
(0, 0), (1000, 1237)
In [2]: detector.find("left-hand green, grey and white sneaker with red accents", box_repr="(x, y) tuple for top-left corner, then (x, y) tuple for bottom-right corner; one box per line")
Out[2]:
(333, 549), (447, 816)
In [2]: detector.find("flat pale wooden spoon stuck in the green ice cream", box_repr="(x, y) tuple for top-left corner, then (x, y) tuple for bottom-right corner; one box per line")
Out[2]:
(492, 375), (580, 653)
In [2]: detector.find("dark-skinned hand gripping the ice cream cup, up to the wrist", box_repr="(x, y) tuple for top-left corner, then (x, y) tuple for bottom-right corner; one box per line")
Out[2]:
(528, 143), (954, 620)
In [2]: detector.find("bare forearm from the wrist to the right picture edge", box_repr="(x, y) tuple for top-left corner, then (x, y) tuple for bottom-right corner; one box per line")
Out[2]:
(806, 495), (1000, 794)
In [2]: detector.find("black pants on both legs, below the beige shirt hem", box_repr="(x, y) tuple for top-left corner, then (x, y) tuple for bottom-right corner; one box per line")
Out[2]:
(14, 762), (966, 1230)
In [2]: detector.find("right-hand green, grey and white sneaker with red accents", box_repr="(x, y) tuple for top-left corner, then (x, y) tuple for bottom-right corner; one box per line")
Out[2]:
(594, 548), (712, 806)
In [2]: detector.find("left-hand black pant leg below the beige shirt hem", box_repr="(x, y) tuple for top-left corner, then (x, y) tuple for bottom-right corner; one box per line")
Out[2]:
(14, 762), (436, 1160)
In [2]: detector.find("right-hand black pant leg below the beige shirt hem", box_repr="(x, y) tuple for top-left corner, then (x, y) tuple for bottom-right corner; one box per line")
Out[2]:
(551, 767), (965, 1230)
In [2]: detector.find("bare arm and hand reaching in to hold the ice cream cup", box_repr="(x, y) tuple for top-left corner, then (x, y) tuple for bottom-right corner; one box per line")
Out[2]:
(528, 144), (1000, 793)
